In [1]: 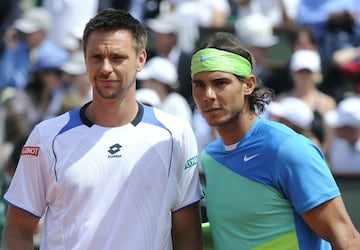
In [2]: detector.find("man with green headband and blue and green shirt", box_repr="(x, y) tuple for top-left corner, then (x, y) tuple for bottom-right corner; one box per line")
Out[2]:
(191, 33), (360, 250)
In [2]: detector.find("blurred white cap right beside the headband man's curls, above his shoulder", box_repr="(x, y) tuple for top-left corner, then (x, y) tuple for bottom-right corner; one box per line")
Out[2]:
(268, 97), (314, 129)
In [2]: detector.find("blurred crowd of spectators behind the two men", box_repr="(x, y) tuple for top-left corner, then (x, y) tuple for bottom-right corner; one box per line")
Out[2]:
(0, 0), (360, 241)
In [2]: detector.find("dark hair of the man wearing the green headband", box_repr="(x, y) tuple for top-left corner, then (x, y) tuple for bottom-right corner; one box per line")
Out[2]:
(195, 32), (275, 113)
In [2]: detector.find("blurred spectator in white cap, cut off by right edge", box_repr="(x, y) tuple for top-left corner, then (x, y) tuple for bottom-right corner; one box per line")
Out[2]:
(325, 96), (360, 174)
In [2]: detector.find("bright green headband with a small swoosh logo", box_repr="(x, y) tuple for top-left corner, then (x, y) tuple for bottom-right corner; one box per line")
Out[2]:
(191, 48), (251, 77)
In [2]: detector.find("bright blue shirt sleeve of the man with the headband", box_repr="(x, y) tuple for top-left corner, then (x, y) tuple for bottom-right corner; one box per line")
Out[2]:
(275, 136), (340, 214)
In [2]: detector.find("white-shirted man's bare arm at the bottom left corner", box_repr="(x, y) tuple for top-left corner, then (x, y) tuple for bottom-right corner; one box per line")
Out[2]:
(3, 205), (39, 250)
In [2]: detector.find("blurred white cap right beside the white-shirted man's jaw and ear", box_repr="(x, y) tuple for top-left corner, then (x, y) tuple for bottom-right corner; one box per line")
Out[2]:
(137, 56), (178, 88)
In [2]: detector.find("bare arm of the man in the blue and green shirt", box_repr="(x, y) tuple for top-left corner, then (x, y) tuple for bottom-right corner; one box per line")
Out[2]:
(302, 196), (360, 250)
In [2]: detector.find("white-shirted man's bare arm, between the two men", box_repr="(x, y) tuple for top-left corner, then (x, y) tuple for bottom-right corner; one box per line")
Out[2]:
(172, 202), (202, 250)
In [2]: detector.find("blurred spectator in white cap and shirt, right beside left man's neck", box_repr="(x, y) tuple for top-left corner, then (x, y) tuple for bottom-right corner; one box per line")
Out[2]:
(137, 57), (192, 124)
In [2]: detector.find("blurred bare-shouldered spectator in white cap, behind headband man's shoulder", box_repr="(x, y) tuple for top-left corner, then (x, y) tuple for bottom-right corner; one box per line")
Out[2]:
(277, 50), (336, 154)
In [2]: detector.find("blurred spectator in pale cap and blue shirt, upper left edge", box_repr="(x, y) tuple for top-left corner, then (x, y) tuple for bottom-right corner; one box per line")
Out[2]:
(0, 7), (68, 89)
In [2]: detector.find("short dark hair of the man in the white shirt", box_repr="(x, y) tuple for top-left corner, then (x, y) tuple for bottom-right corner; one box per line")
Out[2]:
(82, 8), (148, 53)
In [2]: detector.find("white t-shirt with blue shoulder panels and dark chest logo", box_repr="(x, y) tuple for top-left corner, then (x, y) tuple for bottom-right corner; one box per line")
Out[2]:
(4, 102), (203, 250)
